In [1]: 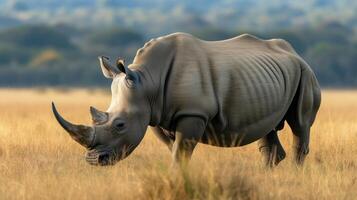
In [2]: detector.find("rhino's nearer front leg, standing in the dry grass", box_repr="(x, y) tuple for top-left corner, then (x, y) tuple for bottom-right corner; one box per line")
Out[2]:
(172, 117), (206, 167)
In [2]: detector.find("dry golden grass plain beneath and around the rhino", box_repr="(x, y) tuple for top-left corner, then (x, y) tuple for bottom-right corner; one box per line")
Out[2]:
(0, 89), (357, 199)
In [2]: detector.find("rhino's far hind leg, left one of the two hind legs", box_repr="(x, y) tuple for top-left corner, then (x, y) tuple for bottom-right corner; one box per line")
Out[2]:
(258, 130), (286, 167)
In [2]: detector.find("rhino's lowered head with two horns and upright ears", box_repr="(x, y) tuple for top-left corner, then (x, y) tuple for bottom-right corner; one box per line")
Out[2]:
(52, 56), (151, 165)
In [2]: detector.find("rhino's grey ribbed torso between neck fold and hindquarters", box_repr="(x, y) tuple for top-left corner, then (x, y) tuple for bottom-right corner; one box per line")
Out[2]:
(157, 32), (301, 146)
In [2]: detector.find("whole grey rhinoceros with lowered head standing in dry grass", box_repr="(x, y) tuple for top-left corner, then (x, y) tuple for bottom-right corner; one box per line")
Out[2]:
(52, 33), (321, 166)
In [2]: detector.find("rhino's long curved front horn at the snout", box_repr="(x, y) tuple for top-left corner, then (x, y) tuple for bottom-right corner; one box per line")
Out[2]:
(52, 102), (95, 148)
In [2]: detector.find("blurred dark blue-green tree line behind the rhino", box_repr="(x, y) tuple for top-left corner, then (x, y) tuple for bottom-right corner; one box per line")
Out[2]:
(0, 22), (357, 87)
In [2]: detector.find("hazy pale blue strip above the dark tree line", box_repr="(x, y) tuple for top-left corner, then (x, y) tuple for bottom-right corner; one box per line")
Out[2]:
(0, 0), (357, 32)
